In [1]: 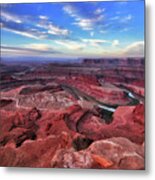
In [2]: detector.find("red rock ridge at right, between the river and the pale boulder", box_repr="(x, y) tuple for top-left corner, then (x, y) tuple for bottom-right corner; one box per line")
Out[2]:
(63, 105), (144, 144)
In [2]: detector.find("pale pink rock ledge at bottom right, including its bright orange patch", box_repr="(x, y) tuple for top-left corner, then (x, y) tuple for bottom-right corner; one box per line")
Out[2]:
(51, 138), (144, 170)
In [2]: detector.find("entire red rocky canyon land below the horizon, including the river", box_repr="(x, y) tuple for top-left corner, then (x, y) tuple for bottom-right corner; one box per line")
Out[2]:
(0, 58), (145, 169)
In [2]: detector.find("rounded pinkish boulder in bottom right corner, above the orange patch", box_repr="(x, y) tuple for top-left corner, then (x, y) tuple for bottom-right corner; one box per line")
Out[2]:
(87, 137), (144, 169)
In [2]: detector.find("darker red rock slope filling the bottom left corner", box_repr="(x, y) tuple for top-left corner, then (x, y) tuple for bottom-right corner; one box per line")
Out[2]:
(0, 132), (71, 167)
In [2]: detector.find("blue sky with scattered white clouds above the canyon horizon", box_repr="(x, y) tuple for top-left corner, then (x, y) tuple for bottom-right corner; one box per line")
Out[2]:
(0, 0), (144, 59)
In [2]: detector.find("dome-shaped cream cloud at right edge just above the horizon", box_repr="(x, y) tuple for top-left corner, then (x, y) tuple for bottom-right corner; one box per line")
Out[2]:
(123, 41), (144, 57)
